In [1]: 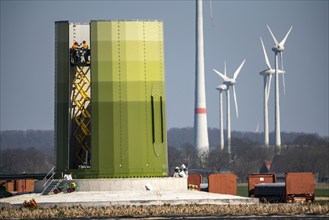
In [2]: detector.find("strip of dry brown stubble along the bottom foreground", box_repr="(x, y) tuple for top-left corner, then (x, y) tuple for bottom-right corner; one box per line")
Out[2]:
(0, 203), (329, 219)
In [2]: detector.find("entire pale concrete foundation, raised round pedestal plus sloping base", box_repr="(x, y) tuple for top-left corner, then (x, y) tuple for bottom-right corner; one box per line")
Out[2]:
(0, 177), (258, 207)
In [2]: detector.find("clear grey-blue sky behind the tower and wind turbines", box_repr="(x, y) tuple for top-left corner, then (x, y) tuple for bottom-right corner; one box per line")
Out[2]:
(0, 0), (329, 136)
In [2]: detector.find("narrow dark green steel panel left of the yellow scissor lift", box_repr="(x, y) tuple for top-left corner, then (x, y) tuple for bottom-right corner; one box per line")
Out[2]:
(55, 21), (70, 172)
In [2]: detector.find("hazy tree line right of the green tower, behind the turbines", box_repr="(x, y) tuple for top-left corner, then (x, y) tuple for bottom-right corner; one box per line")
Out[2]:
(168, 127), (329, 182)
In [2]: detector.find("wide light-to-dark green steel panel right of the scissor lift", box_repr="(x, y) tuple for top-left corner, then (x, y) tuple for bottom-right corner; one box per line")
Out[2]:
(86, 21), (168, 177)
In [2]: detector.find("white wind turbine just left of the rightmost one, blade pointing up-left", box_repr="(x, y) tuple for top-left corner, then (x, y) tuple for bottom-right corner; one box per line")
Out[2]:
(259, 38), (285, 147)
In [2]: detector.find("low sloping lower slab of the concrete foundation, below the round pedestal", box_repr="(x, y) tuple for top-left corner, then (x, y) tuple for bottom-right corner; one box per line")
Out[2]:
(0, 190), (258, 208)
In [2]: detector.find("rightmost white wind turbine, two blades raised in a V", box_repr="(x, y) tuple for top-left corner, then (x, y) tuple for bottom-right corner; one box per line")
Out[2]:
(267, 25), (292, 154)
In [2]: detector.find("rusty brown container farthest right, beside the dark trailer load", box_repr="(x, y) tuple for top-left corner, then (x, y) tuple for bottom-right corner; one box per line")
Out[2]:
(285, 172), (315, 202)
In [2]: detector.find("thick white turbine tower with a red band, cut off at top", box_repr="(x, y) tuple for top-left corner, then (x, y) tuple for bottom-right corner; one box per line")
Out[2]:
(194, 0), (209, 156)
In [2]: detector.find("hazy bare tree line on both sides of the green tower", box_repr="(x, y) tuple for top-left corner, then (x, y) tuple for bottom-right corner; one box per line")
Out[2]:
(0, 128), (329, 182)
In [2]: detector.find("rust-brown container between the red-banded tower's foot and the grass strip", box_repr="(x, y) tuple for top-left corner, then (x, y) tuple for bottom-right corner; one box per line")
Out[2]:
(208, 173), (237, 195)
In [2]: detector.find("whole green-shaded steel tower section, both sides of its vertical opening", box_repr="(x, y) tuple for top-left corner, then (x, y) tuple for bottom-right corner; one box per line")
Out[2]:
(55, 20), (168, 178)
